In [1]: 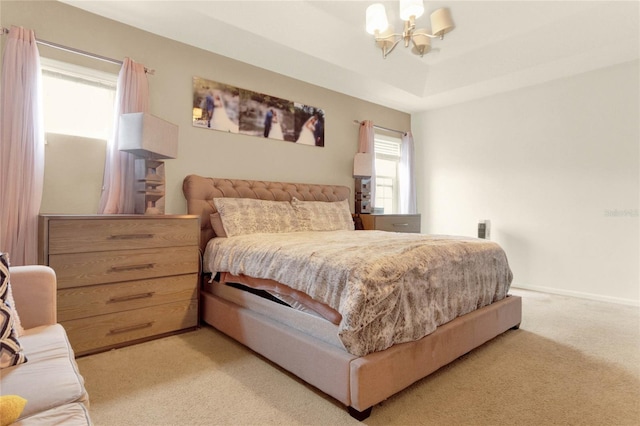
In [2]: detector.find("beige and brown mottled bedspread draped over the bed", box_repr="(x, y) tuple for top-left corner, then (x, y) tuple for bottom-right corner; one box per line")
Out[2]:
(205, 231), (512, 356)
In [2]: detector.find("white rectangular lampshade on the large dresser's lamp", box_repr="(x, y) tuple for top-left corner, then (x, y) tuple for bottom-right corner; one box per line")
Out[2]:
(118, 112), (178, 160)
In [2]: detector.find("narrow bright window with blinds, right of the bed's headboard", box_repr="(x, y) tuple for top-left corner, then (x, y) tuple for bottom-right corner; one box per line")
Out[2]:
(374, 134), (402, 214)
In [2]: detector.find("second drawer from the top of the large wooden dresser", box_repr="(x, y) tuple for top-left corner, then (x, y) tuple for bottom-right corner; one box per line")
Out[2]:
(49, 247), (199, 289)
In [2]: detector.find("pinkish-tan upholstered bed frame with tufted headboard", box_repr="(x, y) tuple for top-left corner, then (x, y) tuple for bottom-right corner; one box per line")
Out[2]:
(183, 175), (522, 420)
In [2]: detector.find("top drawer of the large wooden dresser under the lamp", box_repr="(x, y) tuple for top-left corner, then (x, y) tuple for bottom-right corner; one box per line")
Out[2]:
(47, 218), (199, 255)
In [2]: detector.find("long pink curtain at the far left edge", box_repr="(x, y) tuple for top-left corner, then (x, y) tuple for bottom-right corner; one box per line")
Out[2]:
(0, 27), (44, 266)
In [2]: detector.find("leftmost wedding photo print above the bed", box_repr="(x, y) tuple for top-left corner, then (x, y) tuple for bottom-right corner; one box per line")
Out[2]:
(193, 77), (240, 133)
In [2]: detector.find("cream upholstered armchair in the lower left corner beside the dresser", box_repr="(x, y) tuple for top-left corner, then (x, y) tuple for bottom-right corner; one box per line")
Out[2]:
(0, 265), (91, 426)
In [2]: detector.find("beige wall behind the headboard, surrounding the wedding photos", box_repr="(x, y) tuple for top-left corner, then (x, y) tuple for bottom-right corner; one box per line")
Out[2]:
(0, 1), (411, 214)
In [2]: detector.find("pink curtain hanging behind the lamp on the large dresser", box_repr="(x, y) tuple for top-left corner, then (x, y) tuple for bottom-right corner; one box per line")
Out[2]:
(98, 58), (149, 214)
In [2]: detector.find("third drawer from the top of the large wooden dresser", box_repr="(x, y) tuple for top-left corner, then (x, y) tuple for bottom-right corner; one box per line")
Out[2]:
(58, 274), (198, 321)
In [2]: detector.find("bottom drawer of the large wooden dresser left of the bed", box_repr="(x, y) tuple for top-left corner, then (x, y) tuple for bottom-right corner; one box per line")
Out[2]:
(60, 300), (198, 355)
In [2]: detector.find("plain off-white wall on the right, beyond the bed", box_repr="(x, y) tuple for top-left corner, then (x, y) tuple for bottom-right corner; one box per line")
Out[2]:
(413, 61), (640, 305)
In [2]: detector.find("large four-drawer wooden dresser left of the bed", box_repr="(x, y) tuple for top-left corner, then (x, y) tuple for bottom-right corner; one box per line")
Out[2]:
(38, 215), (200, 356)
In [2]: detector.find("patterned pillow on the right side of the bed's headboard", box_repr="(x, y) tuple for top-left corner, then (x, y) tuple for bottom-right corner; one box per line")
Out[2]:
(291, 197), (354, 231)
